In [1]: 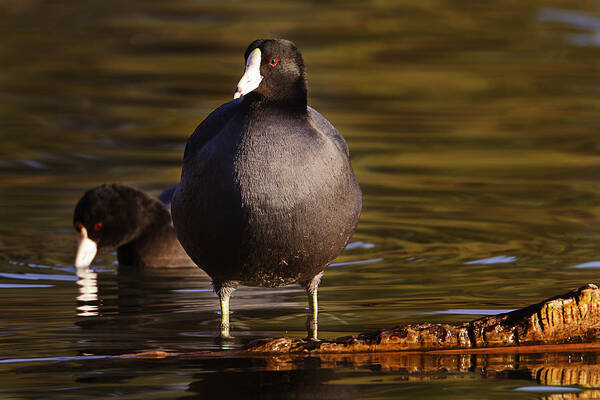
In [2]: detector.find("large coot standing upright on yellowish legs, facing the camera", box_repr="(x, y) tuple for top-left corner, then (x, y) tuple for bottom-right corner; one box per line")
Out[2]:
(172, 39), (362, 339)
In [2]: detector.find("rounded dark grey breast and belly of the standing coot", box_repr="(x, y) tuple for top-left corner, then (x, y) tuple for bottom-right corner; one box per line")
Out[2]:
(173, 115), (360, 285)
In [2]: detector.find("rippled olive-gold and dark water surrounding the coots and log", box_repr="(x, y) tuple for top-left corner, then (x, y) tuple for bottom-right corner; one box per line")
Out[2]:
(0, 0), (600, 399)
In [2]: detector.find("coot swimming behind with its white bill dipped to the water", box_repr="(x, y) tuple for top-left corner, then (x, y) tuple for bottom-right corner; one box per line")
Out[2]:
(73, 184), (193, 267)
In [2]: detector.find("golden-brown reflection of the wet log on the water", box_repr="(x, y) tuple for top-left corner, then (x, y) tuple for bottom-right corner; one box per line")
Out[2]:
(238, 352), (600, 399)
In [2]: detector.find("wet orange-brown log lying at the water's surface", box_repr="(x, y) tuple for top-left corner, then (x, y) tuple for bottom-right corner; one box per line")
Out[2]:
(243, 284), (600, 354)
